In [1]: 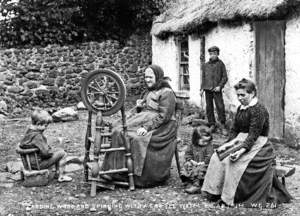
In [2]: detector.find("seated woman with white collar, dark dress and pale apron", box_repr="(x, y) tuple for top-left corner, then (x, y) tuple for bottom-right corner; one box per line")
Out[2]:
(202, 79), (292, 207)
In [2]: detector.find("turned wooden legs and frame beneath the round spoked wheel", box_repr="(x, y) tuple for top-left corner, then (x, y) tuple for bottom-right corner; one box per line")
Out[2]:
(84, 107), (135, 197)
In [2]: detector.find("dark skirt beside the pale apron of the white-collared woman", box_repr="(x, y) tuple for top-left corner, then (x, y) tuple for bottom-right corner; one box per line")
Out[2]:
(234, 141), (292, 207)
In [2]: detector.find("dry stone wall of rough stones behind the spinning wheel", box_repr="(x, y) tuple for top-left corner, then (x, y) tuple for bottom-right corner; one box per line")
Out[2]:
(0, 35), (152, 112)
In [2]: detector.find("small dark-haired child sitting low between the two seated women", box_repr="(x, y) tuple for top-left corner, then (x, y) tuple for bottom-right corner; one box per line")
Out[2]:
(181, 125), (214, 194)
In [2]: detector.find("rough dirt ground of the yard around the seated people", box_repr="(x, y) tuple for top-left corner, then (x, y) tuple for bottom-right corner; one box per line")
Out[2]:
(0, 111), (300, 216)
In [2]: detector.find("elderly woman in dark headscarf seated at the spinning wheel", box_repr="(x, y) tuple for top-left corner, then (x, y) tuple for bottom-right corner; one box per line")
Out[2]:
(102, 65), (177, 187)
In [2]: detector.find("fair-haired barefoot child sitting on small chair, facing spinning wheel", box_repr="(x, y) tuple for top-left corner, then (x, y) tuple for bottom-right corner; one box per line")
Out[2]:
(20, 109), (72, 182)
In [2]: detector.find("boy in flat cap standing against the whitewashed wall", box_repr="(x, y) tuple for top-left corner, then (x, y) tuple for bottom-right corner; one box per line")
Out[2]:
(201, 46), (228, 136)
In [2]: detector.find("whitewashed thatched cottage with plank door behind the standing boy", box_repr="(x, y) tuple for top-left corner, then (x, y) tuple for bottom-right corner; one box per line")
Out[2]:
(151, 0), (300, 145)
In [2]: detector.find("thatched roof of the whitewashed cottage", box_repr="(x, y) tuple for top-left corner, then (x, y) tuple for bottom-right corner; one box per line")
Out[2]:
(151, 0), (300, 37)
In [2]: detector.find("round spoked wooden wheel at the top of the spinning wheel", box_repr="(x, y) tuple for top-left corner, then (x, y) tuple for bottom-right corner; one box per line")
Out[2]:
(81, 69), (126, 116)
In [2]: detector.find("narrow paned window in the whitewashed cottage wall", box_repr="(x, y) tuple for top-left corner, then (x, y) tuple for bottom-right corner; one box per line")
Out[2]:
(179, 36), (190, 90)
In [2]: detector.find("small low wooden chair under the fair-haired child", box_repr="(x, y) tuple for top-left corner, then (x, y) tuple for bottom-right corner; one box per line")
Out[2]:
(16, 145), (49, 187)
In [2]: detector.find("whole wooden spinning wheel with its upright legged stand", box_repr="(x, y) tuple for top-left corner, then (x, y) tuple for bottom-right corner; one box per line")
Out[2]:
(81, 69), (134, 196)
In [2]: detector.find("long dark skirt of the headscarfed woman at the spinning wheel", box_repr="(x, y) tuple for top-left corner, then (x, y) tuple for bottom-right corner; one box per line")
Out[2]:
(102, 121), (177, 187)
